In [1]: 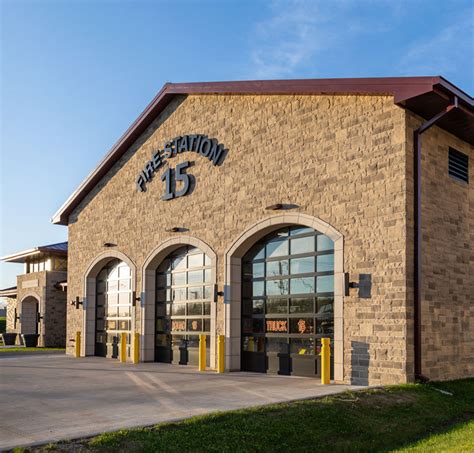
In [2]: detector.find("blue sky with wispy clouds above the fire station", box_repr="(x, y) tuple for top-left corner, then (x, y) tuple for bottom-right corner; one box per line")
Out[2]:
(0, 0), (474, 288)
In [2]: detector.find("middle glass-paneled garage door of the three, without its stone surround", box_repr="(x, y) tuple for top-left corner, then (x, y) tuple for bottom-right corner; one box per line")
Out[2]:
(155, 246), (212, 365)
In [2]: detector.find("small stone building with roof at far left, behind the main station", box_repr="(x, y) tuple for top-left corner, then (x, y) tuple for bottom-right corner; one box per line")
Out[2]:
(0, 242), (67, 347)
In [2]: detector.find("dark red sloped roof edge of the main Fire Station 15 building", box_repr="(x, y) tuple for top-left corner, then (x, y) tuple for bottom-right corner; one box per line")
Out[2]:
(51, 76), (474, 225)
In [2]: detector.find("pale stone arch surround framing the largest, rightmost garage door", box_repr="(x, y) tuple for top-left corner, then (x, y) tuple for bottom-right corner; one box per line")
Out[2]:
(224, 213), (344, 382)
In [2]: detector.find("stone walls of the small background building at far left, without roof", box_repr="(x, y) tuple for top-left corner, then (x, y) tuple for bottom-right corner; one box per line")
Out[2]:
(7, 271), (67, 347)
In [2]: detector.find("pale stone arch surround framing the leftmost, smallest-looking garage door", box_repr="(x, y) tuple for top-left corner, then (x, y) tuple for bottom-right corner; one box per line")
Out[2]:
(81, 250), (137, 356)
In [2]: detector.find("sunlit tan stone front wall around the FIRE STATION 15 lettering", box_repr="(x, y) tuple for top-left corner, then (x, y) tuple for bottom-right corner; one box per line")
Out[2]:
(67, 95), (413, 384)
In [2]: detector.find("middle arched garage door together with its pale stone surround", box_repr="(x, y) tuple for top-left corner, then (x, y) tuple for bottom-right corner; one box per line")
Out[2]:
(141, 235), (217, 368)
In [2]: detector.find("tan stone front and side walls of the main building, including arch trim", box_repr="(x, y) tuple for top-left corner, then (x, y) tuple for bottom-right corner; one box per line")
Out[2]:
(67, 95), (474, 385)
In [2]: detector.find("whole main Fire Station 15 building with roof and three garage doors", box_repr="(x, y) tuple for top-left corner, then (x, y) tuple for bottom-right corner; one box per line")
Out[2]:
(40, 77), (474, 384)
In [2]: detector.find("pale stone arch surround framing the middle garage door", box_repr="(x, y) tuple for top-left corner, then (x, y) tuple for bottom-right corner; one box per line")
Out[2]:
(140, 235), (217, 367)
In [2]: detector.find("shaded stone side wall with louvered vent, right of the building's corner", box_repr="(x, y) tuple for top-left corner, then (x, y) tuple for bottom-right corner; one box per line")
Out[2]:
(407, 112), (474, 380)
